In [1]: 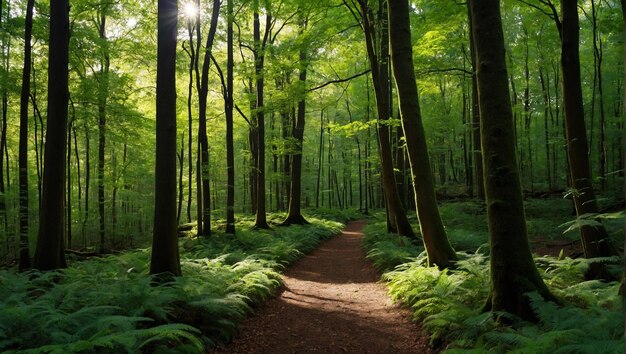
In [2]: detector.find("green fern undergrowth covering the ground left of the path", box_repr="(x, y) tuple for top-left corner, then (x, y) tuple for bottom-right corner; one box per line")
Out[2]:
(0, 212), (343, 353)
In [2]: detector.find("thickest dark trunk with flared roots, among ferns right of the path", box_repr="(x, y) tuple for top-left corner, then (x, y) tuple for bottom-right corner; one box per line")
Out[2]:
(469, 0), (554, 320)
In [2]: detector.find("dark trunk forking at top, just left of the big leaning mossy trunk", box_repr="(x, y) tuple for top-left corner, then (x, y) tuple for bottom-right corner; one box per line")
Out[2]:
(359, 0), (415, 238)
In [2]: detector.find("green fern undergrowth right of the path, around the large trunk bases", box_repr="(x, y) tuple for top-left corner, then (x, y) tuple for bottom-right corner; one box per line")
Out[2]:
(364, 203), (624, 354)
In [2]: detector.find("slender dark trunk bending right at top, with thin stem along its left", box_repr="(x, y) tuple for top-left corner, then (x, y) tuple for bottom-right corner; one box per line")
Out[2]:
(196, 0), (220, 236)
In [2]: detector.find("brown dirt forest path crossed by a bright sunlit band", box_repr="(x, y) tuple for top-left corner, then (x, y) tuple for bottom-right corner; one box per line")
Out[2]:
(216, 221), (430, 354)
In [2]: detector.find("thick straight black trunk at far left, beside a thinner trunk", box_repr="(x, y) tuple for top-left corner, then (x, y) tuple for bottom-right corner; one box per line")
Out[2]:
(33, 0), (70, 270)
